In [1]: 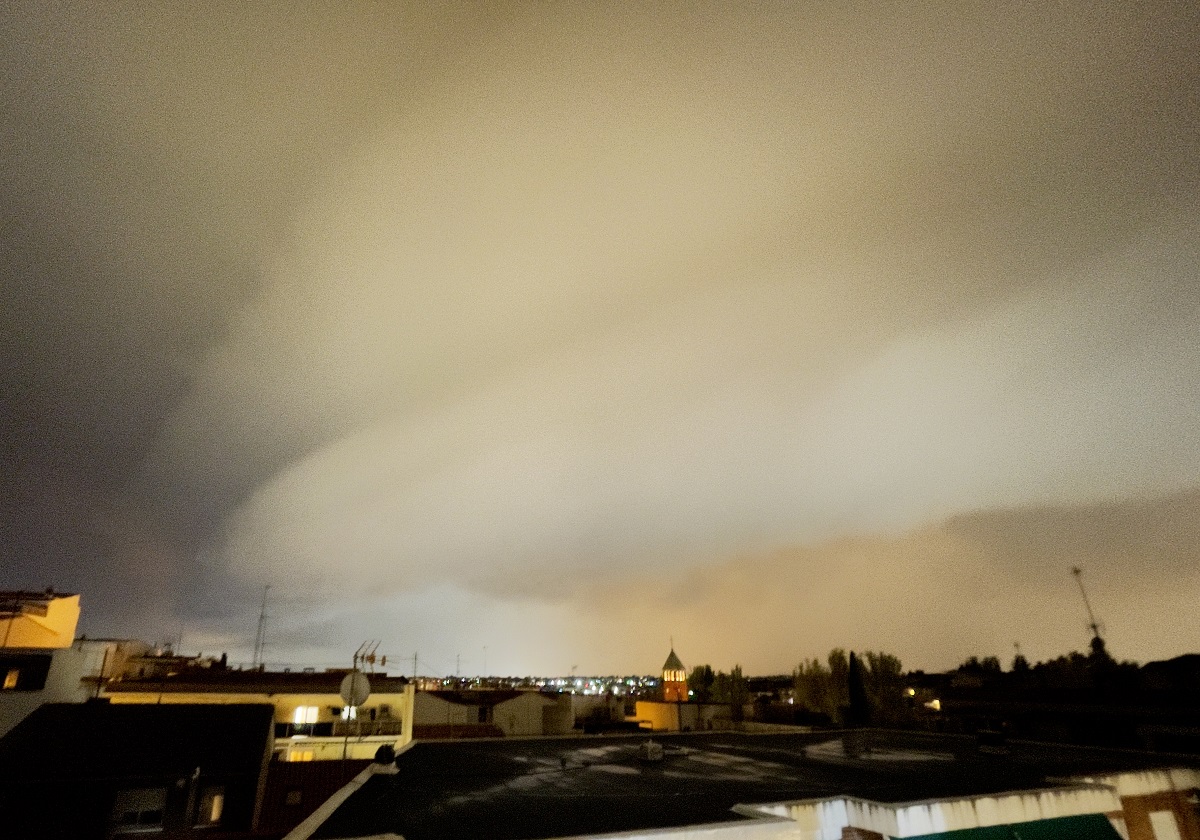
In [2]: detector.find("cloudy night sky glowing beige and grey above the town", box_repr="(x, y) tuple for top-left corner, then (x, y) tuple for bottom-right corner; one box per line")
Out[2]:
(0, 0), (1200, 676)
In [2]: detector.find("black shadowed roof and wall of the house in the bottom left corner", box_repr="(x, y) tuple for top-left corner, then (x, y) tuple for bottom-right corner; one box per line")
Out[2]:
(0, 702), (274, 840)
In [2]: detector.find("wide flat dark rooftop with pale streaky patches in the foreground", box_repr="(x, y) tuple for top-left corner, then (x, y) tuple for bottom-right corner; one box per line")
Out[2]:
(313, 732), (1184, 840)
